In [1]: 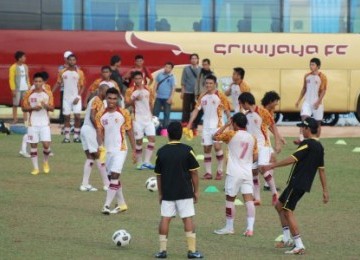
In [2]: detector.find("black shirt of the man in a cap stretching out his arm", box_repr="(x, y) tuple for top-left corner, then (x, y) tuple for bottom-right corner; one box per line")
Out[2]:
(287, 138), (324, 192)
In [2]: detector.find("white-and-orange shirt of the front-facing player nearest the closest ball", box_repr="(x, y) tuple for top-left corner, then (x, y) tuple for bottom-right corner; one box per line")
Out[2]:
(95, 107), (132, 152)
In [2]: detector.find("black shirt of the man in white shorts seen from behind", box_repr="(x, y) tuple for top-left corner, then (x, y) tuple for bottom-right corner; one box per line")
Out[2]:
(154, 142), (200, 201)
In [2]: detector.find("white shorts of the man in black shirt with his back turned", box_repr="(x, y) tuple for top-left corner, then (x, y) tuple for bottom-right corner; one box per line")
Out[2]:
(161, 198), (195, 218)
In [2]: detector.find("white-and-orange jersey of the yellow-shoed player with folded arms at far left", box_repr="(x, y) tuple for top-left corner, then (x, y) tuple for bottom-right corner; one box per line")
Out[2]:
(23, 89), (54, 126)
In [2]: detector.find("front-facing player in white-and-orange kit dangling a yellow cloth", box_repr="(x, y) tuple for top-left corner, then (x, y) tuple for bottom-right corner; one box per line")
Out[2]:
(187, 75), (230, 180)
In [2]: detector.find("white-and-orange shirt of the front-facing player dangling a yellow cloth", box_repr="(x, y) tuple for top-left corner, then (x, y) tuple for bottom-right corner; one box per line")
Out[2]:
(196, 90), (230, 129)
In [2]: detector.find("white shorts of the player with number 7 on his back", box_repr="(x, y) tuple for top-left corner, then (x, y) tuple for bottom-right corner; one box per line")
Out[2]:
(225, 175), (253, 197)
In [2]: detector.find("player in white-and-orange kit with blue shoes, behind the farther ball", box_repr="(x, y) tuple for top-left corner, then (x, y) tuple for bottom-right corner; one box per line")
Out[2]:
(125, 71), (155, 170)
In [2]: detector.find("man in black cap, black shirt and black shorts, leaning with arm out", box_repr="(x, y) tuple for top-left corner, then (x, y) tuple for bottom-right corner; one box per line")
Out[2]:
(261, 117), (329, 254)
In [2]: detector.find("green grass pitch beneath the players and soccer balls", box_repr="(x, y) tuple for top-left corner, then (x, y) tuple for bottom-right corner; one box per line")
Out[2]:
(0, 135), (360, 259)
